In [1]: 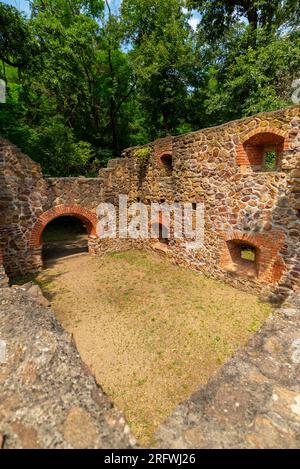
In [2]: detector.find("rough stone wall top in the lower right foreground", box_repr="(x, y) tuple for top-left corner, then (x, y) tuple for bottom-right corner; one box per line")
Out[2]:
(156, 293), (300, 449)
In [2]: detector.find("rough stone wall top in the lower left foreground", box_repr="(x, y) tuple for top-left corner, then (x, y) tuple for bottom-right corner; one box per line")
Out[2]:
(0, 288), (136, 449)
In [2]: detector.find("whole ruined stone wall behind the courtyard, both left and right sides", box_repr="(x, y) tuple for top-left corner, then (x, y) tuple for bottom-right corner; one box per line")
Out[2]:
(0, 107), (300, 297)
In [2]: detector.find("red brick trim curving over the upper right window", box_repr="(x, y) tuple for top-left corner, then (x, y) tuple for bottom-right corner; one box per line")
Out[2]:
(237, 127), (290, 166)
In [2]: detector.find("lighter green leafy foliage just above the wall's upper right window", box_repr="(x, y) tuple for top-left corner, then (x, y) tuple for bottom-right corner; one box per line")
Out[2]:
(196, 31), (300, 124)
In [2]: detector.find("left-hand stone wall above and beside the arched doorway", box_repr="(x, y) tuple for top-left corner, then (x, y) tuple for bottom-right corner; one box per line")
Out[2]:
(0, 140), (102, 276)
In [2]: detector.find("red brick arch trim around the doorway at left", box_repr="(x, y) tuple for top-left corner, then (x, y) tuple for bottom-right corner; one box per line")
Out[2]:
(30, 205), (98, 248)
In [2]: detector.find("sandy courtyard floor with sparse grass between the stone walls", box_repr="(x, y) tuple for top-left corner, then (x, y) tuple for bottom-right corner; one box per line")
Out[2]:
(38, 251), (271, 445)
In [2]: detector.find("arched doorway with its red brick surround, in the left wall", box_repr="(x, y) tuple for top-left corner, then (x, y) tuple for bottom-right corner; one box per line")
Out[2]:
(30, 205), (97, 267)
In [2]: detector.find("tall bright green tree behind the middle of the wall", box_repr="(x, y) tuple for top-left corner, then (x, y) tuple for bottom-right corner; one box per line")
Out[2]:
(121, 0), (195, 138)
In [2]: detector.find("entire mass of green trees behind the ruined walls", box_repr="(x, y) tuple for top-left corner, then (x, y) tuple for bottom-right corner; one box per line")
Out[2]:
(0, 0), (300, 177)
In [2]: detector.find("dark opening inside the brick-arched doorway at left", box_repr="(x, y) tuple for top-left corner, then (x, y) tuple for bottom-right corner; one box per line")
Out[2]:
(42, 216), (88, 262)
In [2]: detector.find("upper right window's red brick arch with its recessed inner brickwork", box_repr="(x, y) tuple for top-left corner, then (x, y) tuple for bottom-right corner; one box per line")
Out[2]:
(237, 127), (289, 166)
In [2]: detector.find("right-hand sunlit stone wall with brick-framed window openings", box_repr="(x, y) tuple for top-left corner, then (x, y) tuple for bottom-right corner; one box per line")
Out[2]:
(96, 107), (300, 297)
